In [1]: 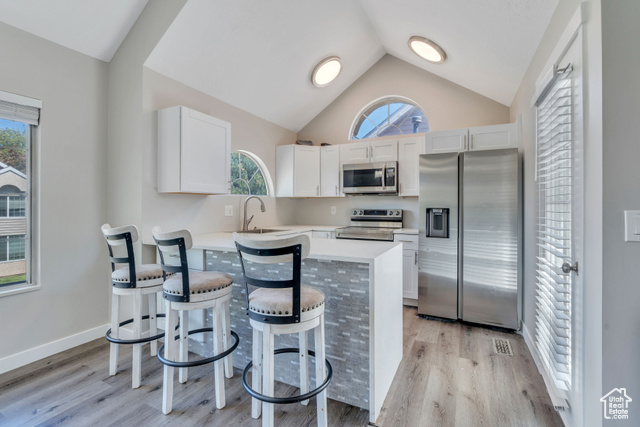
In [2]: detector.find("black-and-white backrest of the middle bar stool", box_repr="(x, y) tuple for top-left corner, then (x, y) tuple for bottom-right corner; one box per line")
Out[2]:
(151, 226), (193, 302)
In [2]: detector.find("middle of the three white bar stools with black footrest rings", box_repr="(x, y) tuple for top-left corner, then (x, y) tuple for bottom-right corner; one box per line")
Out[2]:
(152, 227), (240, 414)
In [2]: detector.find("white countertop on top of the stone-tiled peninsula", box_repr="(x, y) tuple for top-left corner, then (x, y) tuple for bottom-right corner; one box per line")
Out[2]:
(193, 231), (402, 263)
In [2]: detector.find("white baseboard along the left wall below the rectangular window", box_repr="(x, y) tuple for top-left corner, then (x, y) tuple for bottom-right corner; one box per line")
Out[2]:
(0, 324), (109, 374)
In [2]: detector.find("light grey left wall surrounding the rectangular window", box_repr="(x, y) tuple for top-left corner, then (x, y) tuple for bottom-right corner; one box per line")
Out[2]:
(0, 23), (109, 364)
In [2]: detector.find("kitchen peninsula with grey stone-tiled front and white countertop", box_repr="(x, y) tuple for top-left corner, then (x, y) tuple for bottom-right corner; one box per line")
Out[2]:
(184, 227), (402, 422)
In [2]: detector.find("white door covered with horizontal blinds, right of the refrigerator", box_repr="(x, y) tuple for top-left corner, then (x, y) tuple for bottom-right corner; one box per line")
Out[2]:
(535, 31), (584, 406)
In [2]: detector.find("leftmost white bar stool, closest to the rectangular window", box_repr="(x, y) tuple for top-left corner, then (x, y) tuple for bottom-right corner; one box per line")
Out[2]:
(101, 224), (170, 388)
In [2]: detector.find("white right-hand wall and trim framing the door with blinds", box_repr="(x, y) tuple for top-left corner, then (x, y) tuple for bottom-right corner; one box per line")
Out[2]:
(511, 0), (603, 426)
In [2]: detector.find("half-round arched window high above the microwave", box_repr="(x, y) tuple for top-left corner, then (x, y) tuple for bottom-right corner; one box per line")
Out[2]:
(349, 96), (429, 139)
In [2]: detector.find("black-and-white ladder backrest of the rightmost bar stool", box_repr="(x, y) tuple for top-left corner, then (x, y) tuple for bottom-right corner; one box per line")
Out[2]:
(233, 233), (311, 324)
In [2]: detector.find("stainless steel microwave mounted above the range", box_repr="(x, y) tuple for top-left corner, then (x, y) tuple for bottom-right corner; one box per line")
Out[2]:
(342, 162), (398, 195)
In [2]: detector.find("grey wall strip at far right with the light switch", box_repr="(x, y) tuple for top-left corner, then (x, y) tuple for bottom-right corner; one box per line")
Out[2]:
(602, 0), (640, 426)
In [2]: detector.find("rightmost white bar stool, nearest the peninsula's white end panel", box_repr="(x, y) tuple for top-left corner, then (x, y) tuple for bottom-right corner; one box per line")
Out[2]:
(233, 233), (333, 426)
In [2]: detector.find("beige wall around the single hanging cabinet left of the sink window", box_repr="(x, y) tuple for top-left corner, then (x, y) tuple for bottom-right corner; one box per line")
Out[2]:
(141, 68), (296, 247)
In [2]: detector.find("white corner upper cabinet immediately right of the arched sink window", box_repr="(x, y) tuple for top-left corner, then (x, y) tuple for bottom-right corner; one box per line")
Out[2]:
(276, 145), (320, 197)
